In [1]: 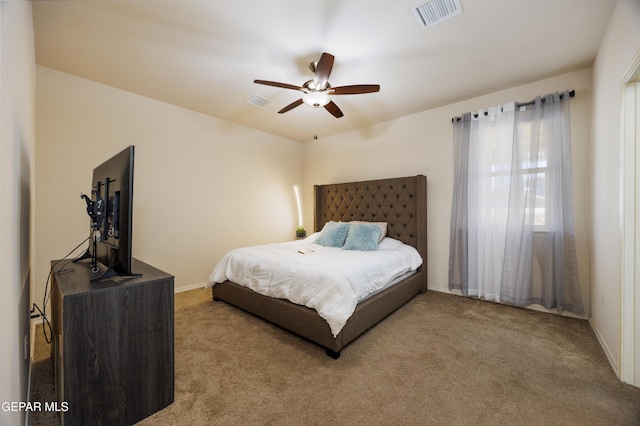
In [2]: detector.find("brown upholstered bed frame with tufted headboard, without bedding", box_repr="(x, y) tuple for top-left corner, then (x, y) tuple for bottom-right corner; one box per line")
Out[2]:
(209, 175), (427, 359)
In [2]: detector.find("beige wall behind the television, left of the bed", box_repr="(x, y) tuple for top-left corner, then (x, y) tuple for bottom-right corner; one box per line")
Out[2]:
(34, 67), (302, 301)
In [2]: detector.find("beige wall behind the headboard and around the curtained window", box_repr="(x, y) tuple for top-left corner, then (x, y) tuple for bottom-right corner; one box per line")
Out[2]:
(304, 69), (591, 320)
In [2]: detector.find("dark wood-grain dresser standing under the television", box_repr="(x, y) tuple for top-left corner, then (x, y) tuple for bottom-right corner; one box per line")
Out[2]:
(51, 259), (174, 426)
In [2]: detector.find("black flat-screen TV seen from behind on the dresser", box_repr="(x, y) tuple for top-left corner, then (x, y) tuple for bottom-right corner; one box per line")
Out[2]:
(81, 145), (139, 282)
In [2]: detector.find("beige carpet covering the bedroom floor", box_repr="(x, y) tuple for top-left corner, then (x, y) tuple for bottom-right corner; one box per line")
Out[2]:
(32, 290), (640, 426)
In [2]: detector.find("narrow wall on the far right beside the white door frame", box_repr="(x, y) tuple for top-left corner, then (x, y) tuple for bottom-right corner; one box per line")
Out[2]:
(589, 0), (640, 372)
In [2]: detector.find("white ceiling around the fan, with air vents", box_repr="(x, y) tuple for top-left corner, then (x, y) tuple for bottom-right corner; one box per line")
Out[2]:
(33, 0), (616, 141)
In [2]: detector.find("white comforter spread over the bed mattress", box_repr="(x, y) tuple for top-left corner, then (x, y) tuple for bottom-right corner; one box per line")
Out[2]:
(207, 233), (422, 337)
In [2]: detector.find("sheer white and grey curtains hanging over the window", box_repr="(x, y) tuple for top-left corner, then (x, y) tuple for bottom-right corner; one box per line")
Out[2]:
(449, 92), (584, 313)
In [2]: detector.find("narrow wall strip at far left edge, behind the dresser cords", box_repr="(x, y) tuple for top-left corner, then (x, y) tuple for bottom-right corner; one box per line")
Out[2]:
(0, 2), (35, 425)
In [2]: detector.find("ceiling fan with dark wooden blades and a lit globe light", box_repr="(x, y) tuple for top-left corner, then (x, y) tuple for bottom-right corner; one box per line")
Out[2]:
(253, 53), (380, 118)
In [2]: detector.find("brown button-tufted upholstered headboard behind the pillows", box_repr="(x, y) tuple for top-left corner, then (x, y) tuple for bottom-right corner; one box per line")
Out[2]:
(314, 175), (427, 289)
